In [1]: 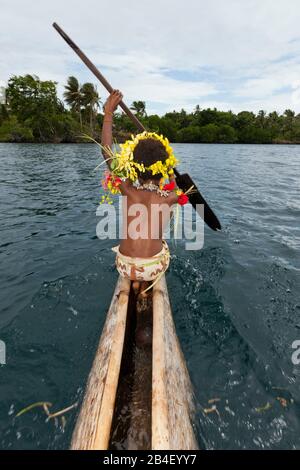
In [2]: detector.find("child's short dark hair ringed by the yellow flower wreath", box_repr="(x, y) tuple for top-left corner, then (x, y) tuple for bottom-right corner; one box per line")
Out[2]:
(133, 138), (168, 181)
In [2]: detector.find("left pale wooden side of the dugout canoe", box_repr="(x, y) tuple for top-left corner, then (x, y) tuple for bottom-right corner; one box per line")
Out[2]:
(71, 277), (130, 450)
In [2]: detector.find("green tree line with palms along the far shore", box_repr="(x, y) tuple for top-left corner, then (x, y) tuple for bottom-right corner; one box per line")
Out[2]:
(0, 75), (300, 144)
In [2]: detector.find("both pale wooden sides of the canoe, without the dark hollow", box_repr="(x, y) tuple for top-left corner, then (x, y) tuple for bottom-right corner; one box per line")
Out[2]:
(71, 276), (198, 450)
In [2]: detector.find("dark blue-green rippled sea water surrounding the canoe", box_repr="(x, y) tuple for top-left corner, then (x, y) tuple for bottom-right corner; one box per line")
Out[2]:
(0, 144), (300, 449)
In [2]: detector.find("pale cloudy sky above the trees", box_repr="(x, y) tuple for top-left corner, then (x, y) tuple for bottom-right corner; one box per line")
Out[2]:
(0, 0), (300, 115)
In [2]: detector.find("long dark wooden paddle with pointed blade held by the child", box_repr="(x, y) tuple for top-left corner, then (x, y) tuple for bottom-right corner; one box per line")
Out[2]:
(53, 23), (221, 230)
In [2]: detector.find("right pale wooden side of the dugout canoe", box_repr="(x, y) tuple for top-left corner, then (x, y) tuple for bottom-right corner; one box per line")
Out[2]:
(152, 276), (198, 450)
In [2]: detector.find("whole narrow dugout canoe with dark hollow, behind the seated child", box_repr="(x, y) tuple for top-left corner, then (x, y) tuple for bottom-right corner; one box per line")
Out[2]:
(71, 276), (198, 450)
